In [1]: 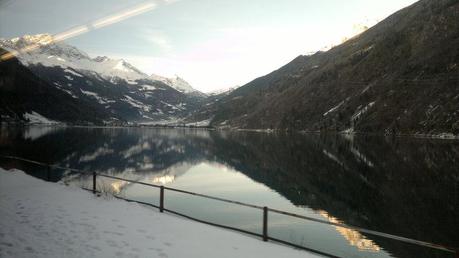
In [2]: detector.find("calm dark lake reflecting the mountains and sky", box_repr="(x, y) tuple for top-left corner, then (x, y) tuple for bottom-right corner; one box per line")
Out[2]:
(0, 126), (459, 257)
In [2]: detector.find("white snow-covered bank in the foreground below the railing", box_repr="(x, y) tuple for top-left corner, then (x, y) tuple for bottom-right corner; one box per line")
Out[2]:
(0, 168), (319, 258)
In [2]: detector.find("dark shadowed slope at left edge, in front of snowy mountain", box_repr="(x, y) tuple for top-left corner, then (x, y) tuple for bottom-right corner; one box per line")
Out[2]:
(0, 49), (108, 124)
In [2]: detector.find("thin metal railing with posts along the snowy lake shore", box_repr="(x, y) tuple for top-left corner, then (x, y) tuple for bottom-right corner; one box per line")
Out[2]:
(0, 155), (459, 257)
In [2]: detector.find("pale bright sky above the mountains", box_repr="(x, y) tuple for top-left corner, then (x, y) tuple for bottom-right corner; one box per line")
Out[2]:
(0, 0), (416, 92)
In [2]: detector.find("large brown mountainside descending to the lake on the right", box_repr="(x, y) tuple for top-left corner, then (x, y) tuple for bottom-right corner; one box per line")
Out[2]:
(212, 0), (459, 134)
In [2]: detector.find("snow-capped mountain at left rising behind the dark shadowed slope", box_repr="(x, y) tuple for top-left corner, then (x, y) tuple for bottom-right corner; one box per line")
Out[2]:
(0, 34), (206, 123)
